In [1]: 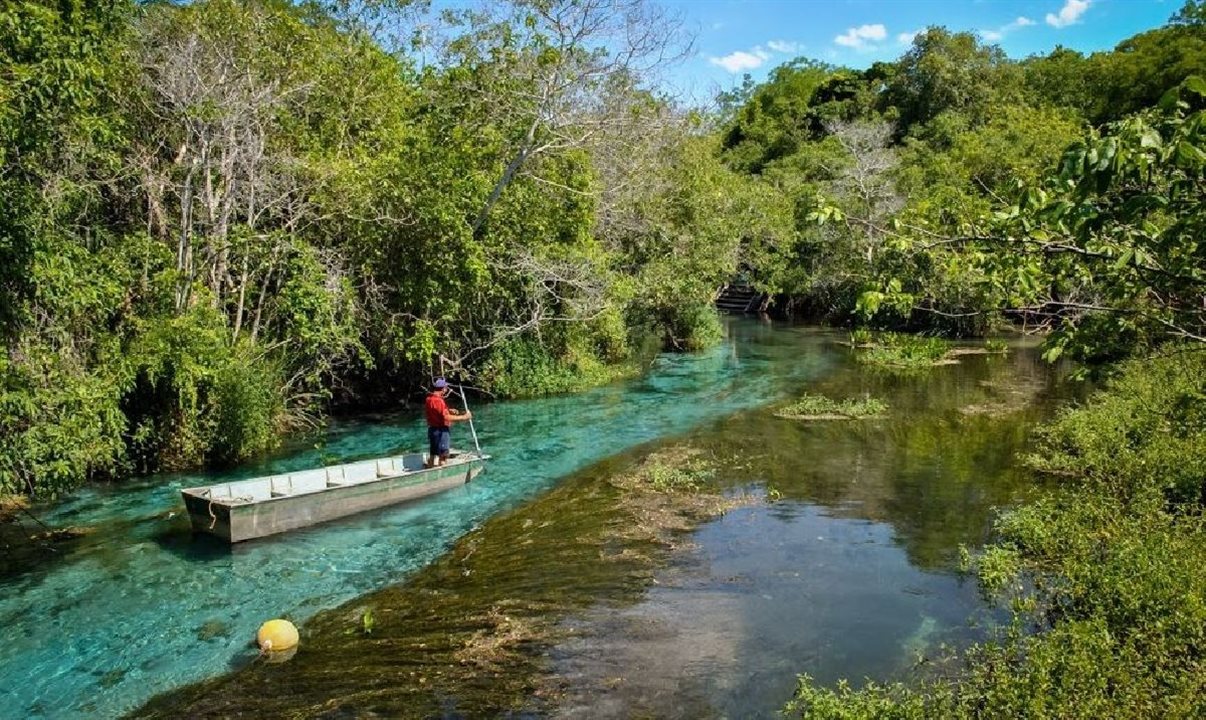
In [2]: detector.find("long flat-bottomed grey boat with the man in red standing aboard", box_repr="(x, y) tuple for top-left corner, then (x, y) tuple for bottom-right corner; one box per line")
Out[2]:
(180, 451), (490, 543)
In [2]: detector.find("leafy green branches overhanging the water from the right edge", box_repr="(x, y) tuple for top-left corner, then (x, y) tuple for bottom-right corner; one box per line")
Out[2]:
(872, 77), (1206, 359)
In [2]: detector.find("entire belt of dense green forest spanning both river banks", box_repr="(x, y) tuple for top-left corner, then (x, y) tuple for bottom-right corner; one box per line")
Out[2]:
(0, 0), (1206, 494)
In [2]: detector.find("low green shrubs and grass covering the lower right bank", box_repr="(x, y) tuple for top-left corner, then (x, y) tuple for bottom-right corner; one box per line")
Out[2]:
(784, 350), (1206, 720)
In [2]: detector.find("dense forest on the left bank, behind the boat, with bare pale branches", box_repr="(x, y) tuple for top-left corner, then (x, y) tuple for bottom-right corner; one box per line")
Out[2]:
(0, 0), (790, 494)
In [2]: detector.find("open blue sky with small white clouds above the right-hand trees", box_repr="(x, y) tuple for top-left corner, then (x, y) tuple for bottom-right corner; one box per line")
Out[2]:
(661, 0), (1183, 95)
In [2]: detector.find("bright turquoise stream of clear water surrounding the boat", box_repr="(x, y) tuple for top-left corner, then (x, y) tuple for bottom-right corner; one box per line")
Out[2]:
(0, 321), (837, 718)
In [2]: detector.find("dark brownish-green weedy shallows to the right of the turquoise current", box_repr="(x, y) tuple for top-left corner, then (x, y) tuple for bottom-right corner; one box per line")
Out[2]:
(139, 337), (1070, 718)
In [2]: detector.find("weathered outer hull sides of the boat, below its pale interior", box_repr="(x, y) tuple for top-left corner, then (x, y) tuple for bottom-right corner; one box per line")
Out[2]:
(181, 457), (486, 543)
